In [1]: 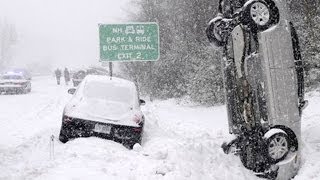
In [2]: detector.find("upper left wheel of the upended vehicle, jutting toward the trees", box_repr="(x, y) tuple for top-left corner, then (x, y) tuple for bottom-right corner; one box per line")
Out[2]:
(206, 17), (226, 47)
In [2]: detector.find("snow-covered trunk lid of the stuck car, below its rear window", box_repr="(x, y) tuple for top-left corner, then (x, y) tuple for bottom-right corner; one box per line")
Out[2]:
(64, 98), (141, 127)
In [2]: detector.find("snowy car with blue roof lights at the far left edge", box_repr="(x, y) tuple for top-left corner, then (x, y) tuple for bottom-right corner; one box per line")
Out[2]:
(0, 72), (31, 94)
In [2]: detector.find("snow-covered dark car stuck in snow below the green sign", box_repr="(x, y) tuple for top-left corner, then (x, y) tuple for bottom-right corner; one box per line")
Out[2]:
(59, 75), (145, 148)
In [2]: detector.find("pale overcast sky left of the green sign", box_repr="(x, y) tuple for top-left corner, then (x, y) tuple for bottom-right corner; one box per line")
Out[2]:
(0, 0), (129, 67)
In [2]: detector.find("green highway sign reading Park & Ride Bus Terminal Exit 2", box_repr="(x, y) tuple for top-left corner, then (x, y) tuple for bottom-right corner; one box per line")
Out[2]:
(99, 23), (160, 62)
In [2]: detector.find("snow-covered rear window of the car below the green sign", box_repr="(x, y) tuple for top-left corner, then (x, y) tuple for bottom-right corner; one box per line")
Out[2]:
(83, 81), (133, 105)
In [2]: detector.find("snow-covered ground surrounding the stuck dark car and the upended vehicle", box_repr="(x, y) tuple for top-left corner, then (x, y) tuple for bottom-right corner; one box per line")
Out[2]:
(0, 77), (320, 180)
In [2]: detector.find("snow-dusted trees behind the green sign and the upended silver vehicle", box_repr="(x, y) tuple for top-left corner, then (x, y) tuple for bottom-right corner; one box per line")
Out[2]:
(120, 0), (320, 105)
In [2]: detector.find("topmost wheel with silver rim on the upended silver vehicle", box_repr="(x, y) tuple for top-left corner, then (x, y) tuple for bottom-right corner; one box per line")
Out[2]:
(242, 0), (280, 31)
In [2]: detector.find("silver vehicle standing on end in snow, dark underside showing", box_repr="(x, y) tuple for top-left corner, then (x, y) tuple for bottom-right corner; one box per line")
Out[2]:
(206, 0), (307, 179)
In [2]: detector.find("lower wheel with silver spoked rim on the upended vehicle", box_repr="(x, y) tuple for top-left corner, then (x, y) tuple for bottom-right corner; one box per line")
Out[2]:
(266, 132), (290, 163)
